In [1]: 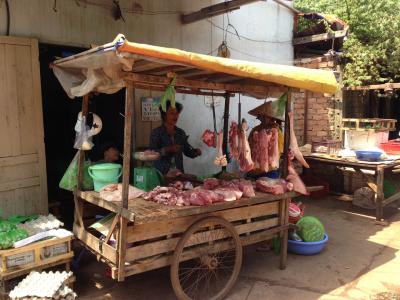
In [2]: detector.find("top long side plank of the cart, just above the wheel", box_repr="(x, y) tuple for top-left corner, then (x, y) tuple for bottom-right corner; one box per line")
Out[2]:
(127, 201), (278, 243)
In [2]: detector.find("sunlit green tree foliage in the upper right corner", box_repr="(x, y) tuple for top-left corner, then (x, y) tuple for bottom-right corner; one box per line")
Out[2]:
(294, 0), (400, 86)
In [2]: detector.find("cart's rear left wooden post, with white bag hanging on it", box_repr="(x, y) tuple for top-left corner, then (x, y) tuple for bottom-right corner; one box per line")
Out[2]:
(74, 94), (89, 230)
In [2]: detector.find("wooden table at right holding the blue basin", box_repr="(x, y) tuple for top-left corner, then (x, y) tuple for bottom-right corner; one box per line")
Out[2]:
(305, 155), (400, 222)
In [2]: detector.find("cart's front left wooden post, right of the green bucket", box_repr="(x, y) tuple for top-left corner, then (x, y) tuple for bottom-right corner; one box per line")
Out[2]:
(118, 81), (135, 281)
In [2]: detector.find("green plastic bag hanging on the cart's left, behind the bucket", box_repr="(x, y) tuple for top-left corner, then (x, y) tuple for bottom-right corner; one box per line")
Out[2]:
(59, 152), (93, 191)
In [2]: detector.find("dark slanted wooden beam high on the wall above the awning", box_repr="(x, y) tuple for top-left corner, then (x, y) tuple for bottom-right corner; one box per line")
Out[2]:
(181, 0), (259, 24)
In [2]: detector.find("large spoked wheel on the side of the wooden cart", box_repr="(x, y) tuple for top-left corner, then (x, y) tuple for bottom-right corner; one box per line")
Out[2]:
(171, 217), (243, 300)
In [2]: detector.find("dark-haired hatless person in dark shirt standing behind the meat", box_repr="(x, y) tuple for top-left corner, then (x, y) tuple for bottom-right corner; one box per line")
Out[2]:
(150, 100), (201, 174)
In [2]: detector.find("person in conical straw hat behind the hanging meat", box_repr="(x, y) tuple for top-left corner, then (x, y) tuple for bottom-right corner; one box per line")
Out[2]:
(247, 100), (285, 179)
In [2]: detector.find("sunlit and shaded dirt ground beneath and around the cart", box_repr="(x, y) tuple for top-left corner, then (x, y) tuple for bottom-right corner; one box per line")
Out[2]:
(75, 197), (400, 300)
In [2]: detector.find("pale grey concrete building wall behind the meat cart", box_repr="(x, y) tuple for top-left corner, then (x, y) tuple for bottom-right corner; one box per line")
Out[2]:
(0, 0), (293, 174)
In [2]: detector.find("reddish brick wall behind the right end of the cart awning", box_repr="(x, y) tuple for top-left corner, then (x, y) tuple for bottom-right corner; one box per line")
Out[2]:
(292, 56), (342, 145)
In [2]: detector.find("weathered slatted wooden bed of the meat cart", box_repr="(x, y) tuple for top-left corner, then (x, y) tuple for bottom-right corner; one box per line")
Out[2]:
(74, 191), (297, 279)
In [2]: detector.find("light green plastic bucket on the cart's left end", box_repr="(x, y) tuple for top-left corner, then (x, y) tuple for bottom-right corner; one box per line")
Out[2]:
(89, 163), (122, 192)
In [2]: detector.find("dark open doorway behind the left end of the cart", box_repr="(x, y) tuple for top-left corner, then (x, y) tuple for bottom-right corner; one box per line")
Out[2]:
(39, 44), (124, 229)
